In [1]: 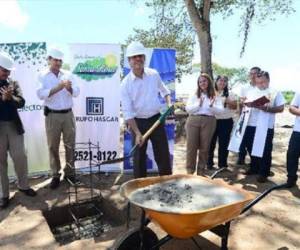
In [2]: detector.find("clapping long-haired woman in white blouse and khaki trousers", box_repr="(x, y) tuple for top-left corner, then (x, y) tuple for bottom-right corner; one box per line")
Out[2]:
(186, 73), (216, 175)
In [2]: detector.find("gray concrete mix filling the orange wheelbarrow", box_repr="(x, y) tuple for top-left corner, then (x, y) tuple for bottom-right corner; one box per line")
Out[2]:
(129, 179), (244, 213)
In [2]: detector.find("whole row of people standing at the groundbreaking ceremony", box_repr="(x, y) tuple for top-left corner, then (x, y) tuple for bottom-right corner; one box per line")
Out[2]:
(0, 42), (300, 209)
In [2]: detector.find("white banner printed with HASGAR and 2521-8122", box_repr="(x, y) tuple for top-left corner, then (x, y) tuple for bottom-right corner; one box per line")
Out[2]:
(70, 44), (121, 171)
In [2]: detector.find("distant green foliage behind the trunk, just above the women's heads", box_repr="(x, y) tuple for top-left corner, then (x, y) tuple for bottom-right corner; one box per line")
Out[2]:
(193, 63), (249, 87)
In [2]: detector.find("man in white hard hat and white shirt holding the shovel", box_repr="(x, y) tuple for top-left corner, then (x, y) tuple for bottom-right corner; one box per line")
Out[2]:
(121, 42), (172, 178)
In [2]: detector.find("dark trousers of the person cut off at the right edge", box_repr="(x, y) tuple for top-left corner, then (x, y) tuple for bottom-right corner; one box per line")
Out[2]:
(286, 131), (300, 182)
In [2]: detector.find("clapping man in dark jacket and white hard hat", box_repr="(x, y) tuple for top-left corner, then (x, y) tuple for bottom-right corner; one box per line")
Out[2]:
(0, 52), (36, 209)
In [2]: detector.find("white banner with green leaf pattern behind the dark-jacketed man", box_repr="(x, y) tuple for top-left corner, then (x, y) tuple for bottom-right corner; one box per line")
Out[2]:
(0, 43), (49, 176)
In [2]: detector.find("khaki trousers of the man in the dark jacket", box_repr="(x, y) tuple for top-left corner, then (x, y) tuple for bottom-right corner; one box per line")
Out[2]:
(0, 121), (29, 198)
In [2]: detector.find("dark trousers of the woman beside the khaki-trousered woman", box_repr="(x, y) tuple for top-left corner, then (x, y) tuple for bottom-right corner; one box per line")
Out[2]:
(207, 118), (233, 168)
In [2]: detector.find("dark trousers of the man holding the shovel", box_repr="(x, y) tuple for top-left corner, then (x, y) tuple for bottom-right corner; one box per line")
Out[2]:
(133, 114), (172, 178)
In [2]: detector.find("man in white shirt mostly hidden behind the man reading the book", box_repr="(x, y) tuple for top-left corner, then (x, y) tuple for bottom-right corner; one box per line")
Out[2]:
(236, 66), (261, 165)
